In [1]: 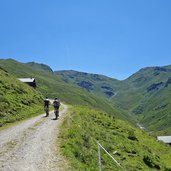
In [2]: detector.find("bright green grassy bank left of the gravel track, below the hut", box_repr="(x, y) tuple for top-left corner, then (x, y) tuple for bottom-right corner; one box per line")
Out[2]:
(0, 68), (43, 126)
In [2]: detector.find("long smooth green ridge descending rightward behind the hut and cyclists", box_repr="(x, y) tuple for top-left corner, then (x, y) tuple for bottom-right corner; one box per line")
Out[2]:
(0, 59), (128, 119)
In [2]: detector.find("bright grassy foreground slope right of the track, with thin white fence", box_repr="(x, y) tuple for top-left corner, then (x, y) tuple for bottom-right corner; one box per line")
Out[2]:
(60, 106), (171, 171)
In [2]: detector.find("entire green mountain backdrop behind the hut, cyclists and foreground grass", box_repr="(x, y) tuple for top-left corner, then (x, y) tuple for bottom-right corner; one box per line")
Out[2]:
(0, 59), (171, 135)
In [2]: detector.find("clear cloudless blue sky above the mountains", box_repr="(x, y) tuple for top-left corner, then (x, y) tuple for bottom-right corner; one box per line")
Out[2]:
(0, 0), (171, 80)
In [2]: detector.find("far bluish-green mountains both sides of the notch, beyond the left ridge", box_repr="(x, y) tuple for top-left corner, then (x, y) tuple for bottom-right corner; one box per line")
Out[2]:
(55, 66), (171, 135)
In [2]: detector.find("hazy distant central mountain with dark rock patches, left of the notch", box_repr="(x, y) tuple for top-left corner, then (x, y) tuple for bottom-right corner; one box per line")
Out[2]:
(55, 70), (120, 99)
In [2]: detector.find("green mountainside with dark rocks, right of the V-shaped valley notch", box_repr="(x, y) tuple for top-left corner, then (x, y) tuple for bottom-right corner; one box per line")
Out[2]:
(113, 66), (171, 135)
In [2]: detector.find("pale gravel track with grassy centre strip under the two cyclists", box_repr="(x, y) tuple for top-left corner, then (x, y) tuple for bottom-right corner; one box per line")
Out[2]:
(0, 105), (69, 171)
